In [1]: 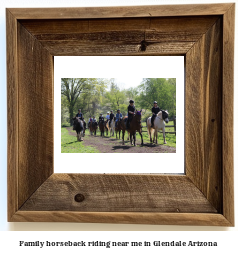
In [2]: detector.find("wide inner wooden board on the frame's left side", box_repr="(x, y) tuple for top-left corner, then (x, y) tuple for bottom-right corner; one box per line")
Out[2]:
(18, 23), (53, 207)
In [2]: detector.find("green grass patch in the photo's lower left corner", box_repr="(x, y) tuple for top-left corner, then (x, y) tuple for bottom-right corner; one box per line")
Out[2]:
(61, 128), (99, 153)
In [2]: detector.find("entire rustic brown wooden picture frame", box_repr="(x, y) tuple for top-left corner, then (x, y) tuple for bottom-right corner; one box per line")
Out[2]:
(6, 3), (235, 226)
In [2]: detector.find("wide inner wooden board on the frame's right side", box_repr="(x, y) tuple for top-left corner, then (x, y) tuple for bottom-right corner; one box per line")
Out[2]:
(185, 19), (222, 212)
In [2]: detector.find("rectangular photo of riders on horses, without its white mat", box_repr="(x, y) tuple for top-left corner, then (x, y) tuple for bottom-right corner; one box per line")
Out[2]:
(61, 77), (176, 153)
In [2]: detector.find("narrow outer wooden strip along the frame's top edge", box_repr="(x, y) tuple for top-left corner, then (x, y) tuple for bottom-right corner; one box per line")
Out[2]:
(9, 3), (232, 20)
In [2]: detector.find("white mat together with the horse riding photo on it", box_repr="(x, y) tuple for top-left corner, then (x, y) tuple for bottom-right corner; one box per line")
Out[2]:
(54, 56), (185, 174)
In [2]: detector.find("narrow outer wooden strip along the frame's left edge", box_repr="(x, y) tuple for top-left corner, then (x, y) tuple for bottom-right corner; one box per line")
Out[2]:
(6, 10), (19, 220)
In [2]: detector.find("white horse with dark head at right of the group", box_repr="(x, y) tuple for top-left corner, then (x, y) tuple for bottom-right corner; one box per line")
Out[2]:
(147, 110), (169, 144)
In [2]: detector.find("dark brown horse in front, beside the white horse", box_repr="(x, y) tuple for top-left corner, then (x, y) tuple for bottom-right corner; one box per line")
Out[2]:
(122, 110), (143, 146)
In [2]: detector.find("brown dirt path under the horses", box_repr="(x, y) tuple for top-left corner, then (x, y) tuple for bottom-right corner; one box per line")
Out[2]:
(66, 127), (176, 153)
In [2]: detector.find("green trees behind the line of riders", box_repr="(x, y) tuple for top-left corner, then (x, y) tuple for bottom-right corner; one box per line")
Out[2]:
(61, 78), (176, 126)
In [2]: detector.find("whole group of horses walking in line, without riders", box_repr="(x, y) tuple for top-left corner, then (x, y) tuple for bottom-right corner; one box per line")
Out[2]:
(73, 110), (169, 146)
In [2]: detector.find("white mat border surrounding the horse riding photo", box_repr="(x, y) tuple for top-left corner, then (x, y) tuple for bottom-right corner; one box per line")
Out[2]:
(54, 56), (184, 174)
